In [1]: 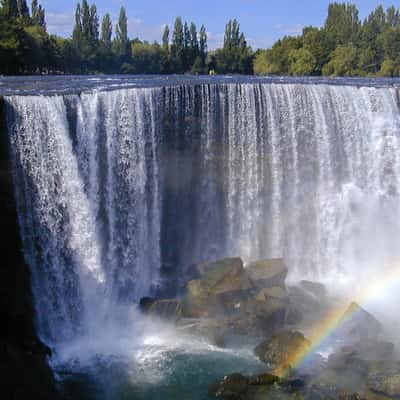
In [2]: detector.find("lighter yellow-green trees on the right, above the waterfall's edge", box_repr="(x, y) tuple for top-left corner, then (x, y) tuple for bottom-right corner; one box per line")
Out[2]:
(254, 2), (400, 77)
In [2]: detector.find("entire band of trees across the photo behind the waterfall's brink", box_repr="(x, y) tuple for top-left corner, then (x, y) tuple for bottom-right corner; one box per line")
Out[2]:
(0, 0), (400, 77)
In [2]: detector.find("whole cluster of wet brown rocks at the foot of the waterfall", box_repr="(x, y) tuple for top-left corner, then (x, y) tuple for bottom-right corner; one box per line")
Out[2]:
(140, 258), (400, 400)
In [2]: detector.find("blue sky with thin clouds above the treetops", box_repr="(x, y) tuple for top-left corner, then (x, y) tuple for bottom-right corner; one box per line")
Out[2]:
(40, 0), (399, 48)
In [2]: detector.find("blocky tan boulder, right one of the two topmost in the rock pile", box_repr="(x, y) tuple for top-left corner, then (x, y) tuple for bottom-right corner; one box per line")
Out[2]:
(246, 258), (288, 289)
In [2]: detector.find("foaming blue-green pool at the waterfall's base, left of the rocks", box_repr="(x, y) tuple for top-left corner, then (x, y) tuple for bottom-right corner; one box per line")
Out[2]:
(52, 317), (264, 400)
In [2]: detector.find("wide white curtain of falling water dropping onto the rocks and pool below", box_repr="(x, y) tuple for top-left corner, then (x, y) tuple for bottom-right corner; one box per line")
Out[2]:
(6, 83), (400, 341)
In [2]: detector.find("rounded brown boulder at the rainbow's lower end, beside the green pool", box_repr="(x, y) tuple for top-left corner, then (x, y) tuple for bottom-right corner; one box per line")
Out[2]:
(254, 331), (311, 376)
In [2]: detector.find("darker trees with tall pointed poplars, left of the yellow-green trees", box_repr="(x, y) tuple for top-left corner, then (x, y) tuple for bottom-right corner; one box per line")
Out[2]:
(0, 0), (253, 74)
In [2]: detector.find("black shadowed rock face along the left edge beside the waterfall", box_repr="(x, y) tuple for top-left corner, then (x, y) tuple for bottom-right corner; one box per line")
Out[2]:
(0, 98), (60, 400)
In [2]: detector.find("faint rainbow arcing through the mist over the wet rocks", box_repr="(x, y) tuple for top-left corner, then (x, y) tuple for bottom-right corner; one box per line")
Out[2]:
(273, 265), (400, 378)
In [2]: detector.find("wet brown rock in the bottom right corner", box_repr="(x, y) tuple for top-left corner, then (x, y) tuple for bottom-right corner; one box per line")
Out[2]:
(367, 361), (400, 398)
